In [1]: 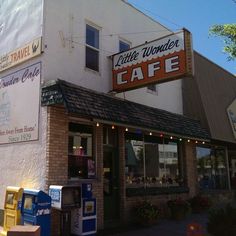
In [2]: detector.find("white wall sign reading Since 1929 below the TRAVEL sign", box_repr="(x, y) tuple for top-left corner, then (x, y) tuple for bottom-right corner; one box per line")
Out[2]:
(0, 63), (41, 144)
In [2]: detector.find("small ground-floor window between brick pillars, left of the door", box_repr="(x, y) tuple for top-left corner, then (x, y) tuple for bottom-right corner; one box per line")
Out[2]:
(68, 123), (95, 179)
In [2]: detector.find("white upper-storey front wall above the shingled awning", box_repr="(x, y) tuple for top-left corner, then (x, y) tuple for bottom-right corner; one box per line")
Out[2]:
(43, 0), (182, 114)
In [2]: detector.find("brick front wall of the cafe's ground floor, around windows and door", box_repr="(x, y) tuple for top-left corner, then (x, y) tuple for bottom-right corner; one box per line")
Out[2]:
(46, 107), (198, 232)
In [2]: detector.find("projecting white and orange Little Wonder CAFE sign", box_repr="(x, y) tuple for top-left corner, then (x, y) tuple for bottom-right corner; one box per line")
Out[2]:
(112, 29), (193, 92)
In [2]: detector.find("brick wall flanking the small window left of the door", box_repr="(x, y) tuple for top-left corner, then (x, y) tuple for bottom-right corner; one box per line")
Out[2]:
(46, 106), (103, 236)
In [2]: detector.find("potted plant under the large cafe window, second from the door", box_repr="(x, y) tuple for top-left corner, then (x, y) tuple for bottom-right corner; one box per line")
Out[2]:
(167, 198), (191, 220)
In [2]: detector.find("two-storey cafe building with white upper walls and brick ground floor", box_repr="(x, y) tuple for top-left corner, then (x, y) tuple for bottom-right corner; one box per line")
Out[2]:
(0, 0), (235, 235)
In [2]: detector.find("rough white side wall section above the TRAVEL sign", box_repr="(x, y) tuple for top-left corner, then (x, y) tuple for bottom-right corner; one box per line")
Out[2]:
(0, 0), (43, 56)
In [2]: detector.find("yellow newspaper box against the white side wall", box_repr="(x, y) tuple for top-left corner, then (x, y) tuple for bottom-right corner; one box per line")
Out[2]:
(0, 186), (24, 236)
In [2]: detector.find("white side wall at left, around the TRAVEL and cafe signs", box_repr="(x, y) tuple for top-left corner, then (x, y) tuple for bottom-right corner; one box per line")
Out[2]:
(0, 0), (47, 209)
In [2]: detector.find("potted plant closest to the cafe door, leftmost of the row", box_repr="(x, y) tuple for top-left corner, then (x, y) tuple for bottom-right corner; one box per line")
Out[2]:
(135, 200), (159, 226)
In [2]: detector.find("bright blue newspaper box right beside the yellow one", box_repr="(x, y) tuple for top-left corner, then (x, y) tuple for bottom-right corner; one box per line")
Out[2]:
(21, 189), (51, 236)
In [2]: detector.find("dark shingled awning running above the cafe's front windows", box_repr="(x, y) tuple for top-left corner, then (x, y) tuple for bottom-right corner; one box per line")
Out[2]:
(41, 80), (210, 139)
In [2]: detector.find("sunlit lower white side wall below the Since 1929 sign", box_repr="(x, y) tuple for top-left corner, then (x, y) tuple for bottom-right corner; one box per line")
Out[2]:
(0, 108), (47, 209)
